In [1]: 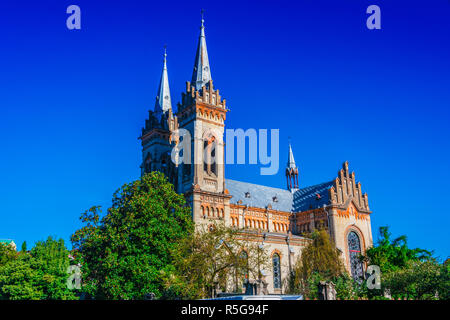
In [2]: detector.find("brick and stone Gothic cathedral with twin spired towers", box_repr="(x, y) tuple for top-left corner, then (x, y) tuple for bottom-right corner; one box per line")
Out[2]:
(140, 19), (372, 294)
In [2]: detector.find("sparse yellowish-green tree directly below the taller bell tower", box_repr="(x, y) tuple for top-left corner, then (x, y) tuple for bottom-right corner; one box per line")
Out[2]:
(172, 222), (269, 298)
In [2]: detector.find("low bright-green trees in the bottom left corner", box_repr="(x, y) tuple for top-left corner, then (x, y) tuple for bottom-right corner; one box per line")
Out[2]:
(0, 237), (77, 300)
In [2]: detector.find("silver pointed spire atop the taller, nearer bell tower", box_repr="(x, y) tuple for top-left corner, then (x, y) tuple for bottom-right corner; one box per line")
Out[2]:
(191, 10), (211, 90)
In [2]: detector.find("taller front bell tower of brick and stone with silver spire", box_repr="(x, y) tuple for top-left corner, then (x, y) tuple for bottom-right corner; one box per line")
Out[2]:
(177, 17), (228, 220)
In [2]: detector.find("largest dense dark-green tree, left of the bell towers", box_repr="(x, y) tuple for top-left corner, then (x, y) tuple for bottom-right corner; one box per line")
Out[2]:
(71, 172), (193, 299)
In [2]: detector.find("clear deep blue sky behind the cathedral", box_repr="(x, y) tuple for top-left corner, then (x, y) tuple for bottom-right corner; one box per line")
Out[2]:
(0, 0), (450, 258)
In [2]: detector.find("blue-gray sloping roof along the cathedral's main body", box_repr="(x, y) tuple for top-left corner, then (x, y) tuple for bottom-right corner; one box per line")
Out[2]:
(225, 179), (333, 212)
